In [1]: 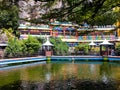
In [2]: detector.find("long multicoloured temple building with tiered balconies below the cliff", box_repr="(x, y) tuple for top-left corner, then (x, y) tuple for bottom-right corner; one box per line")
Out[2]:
(18, 21), (117, 46)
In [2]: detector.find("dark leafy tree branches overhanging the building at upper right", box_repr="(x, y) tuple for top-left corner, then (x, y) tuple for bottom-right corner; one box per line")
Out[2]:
(35, 0), (120, 25)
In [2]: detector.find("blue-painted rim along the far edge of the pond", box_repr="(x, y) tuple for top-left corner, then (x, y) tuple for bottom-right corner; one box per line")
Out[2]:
(0, 56), (120, 65)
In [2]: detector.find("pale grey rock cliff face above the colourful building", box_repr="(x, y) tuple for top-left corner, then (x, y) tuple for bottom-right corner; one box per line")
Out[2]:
(18, 0), (62, 23)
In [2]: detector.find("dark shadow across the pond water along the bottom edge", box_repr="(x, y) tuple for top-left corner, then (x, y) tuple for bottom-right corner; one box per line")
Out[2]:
(0, 78), (119, 90)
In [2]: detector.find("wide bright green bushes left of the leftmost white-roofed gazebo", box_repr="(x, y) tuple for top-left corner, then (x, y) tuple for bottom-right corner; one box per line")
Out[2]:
(5, 36), (41, 57)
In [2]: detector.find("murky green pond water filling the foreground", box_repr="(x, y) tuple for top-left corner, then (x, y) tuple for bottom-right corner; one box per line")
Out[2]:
(0, 61), (120, 90)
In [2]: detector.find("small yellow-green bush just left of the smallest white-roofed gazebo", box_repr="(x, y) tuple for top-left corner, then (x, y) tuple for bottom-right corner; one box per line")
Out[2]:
(75, 44), (89, 54)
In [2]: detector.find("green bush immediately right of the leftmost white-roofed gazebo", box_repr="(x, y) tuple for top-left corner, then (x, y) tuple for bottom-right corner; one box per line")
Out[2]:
(50, 37), (69, 55)
